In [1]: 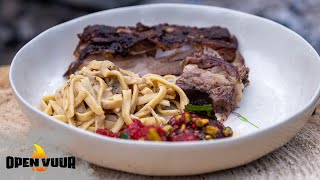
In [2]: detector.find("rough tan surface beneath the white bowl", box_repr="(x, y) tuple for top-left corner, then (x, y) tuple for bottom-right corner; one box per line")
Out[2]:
(0, 67), (320, 179)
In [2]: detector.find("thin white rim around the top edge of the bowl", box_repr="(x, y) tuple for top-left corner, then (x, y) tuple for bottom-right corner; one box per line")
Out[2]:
(9, 3), (320, 148)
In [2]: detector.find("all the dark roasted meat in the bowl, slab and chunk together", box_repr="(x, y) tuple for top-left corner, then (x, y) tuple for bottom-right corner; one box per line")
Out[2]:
(65, 23), (249, 120)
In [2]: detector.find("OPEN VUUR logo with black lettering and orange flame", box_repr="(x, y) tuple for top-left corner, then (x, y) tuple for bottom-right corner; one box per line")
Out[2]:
(6, 144), (76, 172)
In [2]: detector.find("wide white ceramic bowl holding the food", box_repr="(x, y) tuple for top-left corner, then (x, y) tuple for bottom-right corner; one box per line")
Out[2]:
(10, 4), (320, 175)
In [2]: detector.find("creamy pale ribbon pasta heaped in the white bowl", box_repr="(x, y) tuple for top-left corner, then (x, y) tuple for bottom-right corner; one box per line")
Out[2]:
(40, 60), (189, 132)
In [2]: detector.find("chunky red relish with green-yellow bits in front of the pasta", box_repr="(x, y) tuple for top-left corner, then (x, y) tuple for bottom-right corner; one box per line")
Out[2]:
(96, 111), (233, 141)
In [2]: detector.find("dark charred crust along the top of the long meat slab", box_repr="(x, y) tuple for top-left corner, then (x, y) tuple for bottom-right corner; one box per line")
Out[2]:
(64, 23), (238, 76)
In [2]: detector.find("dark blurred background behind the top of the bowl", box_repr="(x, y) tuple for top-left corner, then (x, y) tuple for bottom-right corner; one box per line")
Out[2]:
(0, 0), (320, 65)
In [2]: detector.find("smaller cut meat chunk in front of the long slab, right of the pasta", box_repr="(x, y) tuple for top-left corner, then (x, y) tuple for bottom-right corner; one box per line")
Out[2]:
(177, 48), (249, 120)
